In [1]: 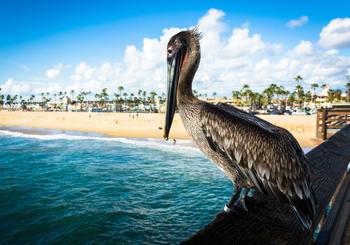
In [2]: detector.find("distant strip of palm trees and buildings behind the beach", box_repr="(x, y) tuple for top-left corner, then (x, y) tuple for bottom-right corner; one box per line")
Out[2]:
(0, 75), (350, 112)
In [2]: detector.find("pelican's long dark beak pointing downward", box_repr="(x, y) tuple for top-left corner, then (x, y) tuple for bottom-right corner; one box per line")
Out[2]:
(163, 50), (182, 140)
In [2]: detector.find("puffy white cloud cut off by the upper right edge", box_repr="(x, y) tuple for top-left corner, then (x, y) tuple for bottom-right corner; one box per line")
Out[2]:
(319, 18), (350, 48)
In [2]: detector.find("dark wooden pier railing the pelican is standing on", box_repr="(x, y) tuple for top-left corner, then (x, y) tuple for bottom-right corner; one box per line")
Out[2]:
(182, 125), (350, 244)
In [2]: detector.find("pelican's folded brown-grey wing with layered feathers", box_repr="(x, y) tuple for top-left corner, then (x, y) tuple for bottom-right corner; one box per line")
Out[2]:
(201, 104), (315, 228)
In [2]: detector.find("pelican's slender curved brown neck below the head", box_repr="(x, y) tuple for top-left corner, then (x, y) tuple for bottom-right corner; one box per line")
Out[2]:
(177, 45), (200, 103)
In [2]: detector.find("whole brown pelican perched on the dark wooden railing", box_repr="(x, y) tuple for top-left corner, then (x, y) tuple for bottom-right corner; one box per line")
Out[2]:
(164, 30), (316, 229)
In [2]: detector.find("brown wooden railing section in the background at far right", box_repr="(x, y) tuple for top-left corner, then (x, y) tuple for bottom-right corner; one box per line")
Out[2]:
(316, 106), (350, 140)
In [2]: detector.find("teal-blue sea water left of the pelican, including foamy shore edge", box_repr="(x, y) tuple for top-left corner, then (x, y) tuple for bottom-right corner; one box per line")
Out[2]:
(0, 129), (232, 244)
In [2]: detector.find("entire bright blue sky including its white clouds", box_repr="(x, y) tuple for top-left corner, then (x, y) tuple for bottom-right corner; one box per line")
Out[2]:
(0, 0), (350, 96)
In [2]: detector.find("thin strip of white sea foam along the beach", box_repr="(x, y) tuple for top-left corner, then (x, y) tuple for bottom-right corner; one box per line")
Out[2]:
(0, 129), (199, 152)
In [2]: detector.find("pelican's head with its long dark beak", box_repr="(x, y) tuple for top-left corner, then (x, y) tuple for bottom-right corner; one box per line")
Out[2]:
(163, 29), (200, 140)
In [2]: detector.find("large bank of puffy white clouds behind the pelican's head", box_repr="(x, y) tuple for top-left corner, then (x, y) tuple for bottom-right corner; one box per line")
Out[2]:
(1, 9), (350, 95)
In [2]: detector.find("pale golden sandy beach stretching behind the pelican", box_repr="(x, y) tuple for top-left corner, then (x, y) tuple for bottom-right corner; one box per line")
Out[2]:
(0, 111), (321, 147)
